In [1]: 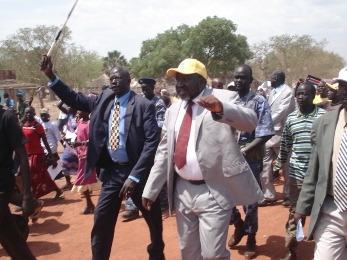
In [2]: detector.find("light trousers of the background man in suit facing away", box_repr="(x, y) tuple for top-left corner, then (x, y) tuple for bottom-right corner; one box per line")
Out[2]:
(260, 147), (290, 200)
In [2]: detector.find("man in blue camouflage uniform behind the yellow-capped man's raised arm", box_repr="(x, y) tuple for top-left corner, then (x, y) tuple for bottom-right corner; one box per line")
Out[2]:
(228, 65), (275, 259)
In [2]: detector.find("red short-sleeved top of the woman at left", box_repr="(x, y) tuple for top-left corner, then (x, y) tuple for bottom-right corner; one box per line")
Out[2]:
(22, 119), (45, 154)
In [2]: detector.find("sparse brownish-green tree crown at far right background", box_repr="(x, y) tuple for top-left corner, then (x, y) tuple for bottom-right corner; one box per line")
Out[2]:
(248, 34), (345, 85)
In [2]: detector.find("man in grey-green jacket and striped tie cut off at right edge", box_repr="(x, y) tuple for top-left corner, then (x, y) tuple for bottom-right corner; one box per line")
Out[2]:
(294, 68), (347, 260)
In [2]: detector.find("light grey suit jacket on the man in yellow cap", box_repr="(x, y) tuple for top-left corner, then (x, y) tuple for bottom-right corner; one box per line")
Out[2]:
(142, 88), (263, 214)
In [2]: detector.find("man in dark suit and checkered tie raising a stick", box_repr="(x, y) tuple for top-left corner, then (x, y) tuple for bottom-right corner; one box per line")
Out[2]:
(41, 56), (164, 260)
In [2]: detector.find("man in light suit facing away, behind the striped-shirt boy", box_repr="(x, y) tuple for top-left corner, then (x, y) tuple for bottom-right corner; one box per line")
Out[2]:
(258, 70), (295, 207)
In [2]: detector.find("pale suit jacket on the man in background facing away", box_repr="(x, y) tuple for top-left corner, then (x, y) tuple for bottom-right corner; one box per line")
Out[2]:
(266, 84), (295, 147)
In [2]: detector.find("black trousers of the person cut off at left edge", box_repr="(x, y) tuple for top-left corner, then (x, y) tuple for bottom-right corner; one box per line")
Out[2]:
(0, 192), (36, 260)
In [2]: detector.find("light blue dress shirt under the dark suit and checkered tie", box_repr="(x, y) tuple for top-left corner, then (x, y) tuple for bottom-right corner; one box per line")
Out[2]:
(107, 91), (130, 162)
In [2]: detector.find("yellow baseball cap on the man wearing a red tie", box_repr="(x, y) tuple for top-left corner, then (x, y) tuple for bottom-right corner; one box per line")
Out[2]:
(166, 59), (207, 79)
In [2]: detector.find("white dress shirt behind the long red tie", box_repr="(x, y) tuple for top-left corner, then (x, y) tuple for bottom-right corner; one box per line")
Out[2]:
(175, 90), (205, 180)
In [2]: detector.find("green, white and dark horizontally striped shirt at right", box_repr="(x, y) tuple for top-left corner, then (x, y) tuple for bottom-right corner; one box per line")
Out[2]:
(273, 107), (325, 181)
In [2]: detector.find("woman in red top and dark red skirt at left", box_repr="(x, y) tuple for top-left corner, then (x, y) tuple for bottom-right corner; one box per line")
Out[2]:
(22, 106), (62, 200)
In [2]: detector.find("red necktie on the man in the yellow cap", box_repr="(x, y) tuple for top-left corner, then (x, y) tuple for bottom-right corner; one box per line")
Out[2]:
(174, 101), (194, 169)
